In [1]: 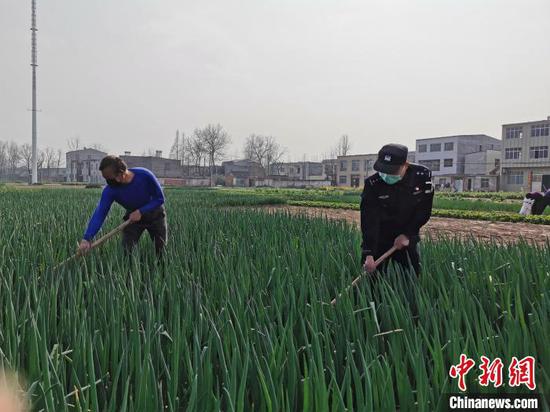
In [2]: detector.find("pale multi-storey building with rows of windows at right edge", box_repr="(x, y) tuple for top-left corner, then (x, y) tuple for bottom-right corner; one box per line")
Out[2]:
(501, 116), (550, 192)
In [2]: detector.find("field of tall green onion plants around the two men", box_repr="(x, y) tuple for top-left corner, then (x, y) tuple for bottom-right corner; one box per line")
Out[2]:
(0, 188), (550, 412)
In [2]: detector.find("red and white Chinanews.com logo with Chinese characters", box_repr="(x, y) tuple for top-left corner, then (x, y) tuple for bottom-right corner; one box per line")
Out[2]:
(447, 354), (542, 411)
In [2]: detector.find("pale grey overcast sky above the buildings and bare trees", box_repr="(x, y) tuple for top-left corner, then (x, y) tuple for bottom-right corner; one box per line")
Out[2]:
(0, 0), (550, 160)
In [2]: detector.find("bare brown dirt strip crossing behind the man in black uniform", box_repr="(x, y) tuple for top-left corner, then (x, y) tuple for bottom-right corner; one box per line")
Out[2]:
(254, 205), (550, 244)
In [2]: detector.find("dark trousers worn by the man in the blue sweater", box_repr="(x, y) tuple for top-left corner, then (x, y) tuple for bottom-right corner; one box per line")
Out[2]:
(122, 205), (168, 257)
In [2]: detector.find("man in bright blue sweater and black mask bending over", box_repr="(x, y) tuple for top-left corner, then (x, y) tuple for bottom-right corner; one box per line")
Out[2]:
(78, 156), (167, 257)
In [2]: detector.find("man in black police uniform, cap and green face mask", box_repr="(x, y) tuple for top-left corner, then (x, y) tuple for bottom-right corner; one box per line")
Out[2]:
(361, 144), (434, 275)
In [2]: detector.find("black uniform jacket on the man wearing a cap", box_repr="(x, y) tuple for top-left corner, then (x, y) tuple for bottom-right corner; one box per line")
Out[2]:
(361, 163), (434, 256)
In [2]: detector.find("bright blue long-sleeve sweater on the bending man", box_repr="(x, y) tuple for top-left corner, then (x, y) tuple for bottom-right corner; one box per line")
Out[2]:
(84, 167), (164, 241)
